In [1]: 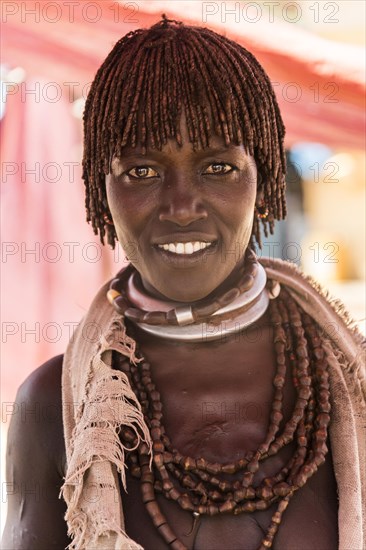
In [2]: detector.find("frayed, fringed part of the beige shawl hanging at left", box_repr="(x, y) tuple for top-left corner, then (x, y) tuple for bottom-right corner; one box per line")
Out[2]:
(61, 314), (151, 550)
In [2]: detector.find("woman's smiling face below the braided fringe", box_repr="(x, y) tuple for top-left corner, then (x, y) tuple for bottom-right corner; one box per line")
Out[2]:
(106, 122), (257, 302)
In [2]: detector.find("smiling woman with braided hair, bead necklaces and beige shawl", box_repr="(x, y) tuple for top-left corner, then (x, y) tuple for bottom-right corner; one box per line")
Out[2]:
(4, 17), (365, 550)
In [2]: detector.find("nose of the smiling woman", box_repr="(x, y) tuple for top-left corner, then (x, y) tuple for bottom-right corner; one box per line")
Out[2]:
(159, 176), (207, 227)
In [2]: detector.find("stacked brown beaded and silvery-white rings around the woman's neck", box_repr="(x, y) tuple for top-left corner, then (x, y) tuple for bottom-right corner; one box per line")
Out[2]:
(107, 250), (275, 342)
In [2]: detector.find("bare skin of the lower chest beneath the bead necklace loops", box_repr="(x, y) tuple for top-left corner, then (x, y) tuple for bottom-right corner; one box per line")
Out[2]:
(123, 466), (338, 550)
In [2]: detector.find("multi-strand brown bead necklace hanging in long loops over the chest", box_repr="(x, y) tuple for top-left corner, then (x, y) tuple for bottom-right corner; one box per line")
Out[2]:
(115, 290), (330, 550)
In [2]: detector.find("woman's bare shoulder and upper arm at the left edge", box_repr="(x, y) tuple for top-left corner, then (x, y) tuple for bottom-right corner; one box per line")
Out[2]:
(2, 355), (70, 550)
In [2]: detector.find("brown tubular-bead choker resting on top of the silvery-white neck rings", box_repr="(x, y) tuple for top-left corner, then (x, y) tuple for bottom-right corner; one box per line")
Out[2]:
(107, 249), (258, 326)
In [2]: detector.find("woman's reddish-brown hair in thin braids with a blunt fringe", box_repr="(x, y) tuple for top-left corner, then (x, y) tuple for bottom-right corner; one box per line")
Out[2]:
(83, 16), (286, 247)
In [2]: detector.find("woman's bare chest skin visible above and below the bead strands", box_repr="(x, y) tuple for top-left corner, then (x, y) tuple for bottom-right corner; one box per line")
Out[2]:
(118, 325), (338, 550)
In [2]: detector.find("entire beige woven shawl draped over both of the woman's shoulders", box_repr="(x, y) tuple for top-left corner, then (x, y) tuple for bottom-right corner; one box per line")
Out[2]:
(61, 259), (366, 550)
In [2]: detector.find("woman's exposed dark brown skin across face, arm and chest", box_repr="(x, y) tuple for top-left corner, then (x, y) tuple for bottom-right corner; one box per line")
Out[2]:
(3, 125), (338, 550)
